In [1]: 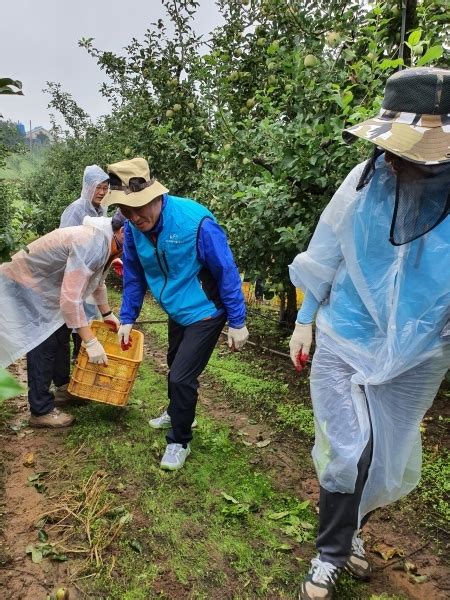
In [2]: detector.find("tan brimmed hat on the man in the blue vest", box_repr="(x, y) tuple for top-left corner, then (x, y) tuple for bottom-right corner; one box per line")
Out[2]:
(102, 158), (169, 208)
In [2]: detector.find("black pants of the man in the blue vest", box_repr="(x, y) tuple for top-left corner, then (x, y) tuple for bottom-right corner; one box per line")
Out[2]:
(166, 315), (226, 446)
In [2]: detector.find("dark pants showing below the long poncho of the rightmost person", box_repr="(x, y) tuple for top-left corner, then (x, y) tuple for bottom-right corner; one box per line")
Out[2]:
(316, 394), (373, 567)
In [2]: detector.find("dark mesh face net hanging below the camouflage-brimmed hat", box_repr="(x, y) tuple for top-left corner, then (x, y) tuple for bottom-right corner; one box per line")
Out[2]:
(389, 165), (450, 246)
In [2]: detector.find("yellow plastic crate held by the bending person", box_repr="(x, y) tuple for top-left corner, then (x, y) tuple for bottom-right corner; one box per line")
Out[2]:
(68, 321), (144, 406)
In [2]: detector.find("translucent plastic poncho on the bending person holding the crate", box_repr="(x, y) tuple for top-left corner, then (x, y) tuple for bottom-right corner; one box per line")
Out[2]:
(0, 217), (112, 367)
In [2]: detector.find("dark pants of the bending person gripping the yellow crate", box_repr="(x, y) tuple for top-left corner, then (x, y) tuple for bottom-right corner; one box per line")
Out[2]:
(27, 325), (70, 416)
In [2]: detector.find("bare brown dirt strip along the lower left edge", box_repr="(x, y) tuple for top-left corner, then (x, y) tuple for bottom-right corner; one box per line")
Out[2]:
(0, 363), (79, 600)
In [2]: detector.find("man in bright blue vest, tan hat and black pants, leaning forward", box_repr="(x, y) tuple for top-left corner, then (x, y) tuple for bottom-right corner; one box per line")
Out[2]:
(102, 158), (248, 471)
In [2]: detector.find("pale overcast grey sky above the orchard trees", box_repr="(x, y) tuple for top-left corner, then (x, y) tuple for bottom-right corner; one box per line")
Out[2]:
(0, 0), (221, 131)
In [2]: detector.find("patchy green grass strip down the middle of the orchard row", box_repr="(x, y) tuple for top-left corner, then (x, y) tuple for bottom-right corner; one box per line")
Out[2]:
(51, 294), (370, 600)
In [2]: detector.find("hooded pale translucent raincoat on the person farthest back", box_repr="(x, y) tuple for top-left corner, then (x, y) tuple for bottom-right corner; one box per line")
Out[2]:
(60, 165), (109, 227)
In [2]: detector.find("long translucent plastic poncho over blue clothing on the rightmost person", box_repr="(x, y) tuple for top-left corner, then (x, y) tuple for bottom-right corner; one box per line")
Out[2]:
(289, 156), (450, 518)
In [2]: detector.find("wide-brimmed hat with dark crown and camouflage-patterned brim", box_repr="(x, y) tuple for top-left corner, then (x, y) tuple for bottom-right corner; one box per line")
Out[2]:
(342, 67), (450, 165)
